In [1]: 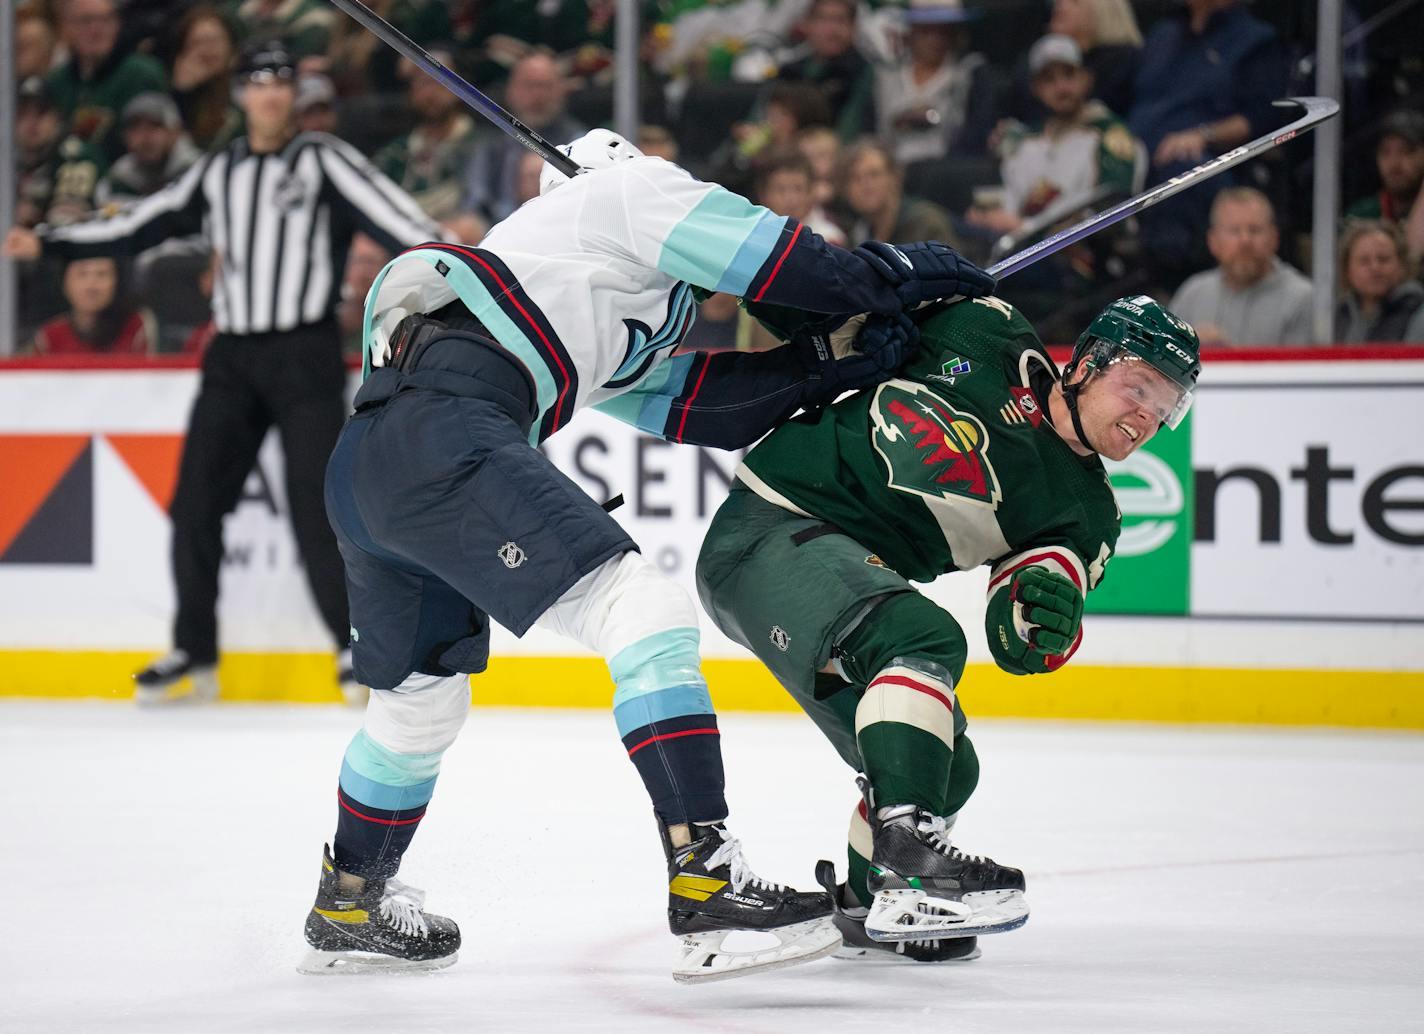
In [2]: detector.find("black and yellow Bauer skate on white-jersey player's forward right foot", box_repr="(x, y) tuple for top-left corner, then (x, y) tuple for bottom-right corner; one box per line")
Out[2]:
(662, 823), (840, 984)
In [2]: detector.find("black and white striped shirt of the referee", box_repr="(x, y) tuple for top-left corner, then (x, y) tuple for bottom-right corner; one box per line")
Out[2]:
(43, 132), (443, 335)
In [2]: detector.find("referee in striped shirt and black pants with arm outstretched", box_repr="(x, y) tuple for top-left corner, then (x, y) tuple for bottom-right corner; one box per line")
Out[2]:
(6, 43), (441, 702)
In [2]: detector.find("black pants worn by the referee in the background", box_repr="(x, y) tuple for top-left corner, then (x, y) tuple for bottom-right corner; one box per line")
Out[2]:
(169, 320), (350, 664)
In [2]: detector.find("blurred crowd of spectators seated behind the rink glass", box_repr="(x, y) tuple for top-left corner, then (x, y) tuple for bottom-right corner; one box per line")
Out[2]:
(13, 0), (1424, 355)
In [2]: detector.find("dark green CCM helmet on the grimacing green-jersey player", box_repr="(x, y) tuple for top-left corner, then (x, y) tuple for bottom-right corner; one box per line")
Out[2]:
(1064, 295), (1202, 427)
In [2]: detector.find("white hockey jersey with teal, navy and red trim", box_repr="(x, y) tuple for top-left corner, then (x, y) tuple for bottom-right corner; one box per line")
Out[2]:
(365, 157), (897, 442)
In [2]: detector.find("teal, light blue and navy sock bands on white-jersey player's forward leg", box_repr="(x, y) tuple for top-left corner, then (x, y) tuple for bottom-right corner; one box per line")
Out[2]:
(608, 628), (726, 826)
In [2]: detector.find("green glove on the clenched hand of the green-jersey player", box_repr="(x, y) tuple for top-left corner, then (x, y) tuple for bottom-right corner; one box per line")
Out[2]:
(984, 567), (1082, 675)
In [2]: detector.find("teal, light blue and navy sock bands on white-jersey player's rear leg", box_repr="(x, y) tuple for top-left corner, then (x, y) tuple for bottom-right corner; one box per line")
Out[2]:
(332, 729), (444, 879)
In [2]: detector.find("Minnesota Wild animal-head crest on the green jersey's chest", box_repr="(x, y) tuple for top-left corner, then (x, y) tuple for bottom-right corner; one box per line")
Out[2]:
(870, 380), (1004, 507)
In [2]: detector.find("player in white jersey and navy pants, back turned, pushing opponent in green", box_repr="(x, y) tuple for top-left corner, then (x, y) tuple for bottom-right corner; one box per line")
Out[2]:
(303, 130), (994, 981)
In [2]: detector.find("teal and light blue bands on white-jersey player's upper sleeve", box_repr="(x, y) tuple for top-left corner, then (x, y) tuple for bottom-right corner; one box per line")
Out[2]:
(658, 187), (786, 295)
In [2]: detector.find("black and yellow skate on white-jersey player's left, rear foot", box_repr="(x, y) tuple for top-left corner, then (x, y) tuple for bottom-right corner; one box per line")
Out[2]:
(296, 847), (460, 976)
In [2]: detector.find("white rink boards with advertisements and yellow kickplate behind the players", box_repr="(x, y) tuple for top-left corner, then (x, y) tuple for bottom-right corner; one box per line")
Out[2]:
(0, 349), (1424, 728)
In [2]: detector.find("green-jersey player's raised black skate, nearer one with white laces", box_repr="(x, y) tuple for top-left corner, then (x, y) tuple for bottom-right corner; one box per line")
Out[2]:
(866, 805), (1028, 941)
